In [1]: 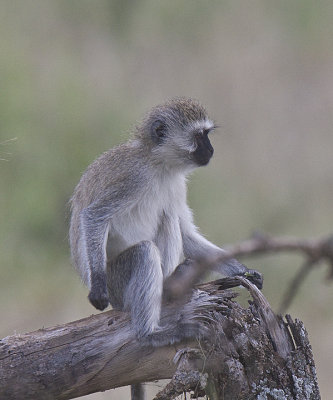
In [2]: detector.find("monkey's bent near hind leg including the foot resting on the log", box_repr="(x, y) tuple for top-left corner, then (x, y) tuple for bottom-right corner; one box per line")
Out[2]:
(107, 252), (207, 347)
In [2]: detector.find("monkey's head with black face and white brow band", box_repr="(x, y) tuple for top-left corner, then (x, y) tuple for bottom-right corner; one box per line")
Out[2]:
(138, 98), (215, 170)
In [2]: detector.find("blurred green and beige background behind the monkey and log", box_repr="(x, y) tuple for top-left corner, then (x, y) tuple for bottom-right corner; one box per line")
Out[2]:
(0, 0), (333, 400)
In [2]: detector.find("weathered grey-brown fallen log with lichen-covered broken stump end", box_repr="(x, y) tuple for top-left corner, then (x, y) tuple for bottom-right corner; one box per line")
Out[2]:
(0, 278), (320, 400)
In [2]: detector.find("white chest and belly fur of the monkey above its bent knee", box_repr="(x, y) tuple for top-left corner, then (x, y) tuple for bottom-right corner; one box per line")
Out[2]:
(107, 174), (186, 276)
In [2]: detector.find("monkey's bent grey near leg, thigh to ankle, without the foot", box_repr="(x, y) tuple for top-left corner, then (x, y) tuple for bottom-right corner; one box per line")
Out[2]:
(107, 241), (163, 339)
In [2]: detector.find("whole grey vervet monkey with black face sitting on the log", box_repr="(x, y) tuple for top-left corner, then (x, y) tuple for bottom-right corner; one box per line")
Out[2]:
(70, 98), (262, 344)
